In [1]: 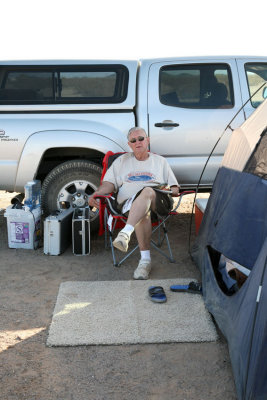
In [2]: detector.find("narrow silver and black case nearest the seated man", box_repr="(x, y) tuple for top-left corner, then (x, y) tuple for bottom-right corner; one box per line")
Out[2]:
(72, 207), (91, 256)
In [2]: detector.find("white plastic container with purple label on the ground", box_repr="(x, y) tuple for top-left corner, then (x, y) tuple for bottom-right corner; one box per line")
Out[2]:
(4, 206), (41, 249)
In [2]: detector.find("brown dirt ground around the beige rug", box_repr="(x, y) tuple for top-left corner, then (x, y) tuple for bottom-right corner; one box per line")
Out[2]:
(0, 191), (239, 400)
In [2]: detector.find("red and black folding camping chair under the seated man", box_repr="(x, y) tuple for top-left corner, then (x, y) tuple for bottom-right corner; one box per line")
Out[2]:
(96, 151), (194, 267)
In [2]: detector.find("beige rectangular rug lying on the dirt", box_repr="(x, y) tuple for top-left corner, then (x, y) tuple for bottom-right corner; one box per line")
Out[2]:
(47, 279), (217, 346)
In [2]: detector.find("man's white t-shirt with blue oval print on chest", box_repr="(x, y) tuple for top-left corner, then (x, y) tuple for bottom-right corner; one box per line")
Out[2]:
(103, 153), (179, 204)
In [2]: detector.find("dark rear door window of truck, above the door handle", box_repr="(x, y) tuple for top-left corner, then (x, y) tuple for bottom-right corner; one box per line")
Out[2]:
(159, 64), (234, 109)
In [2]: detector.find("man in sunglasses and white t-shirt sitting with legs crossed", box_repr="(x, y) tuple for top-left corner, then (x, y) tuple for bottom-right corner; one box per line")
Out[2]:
(89, 127), (179, 279)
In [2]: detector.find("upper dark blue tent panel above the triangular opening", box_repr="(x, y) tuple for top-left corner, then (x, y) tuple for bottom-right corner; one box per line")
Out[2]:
(199, 167), (267, 269)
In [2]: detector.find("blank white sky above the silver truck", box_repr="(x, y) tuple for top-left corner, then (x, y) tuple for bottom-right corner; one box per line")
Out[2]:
(0, 0), (267, 60)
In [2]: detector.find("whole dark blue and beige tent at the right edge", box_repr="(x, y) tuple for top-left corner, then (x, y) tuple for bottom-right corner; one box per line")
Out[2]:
(191, 100), (267, 400)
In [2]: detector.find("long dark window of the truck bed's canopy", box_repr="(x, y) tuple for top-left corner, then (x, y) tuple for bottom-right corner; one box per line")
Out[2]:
(0, 64), (129, 104)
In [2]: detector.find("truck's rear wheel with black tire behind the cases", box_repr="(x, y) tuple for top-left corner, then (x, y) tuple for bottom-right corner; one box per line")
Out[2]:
(42, 160), (102, 231)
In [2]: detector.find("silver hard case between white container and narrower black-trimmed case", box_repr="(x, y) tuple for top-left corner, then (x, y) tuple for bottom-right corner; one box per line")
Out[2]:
(44, 208), (73, 256)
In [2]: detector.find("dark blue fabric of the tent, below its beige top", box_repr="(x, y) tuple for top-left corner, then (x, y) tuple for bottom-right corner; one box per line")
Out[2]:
(192, 168), (267, 400)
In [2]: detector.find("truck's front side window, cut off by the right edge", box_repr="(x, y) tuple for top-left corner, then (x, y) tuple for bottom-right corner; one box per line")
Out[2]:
(245, 63), (267, 108)
